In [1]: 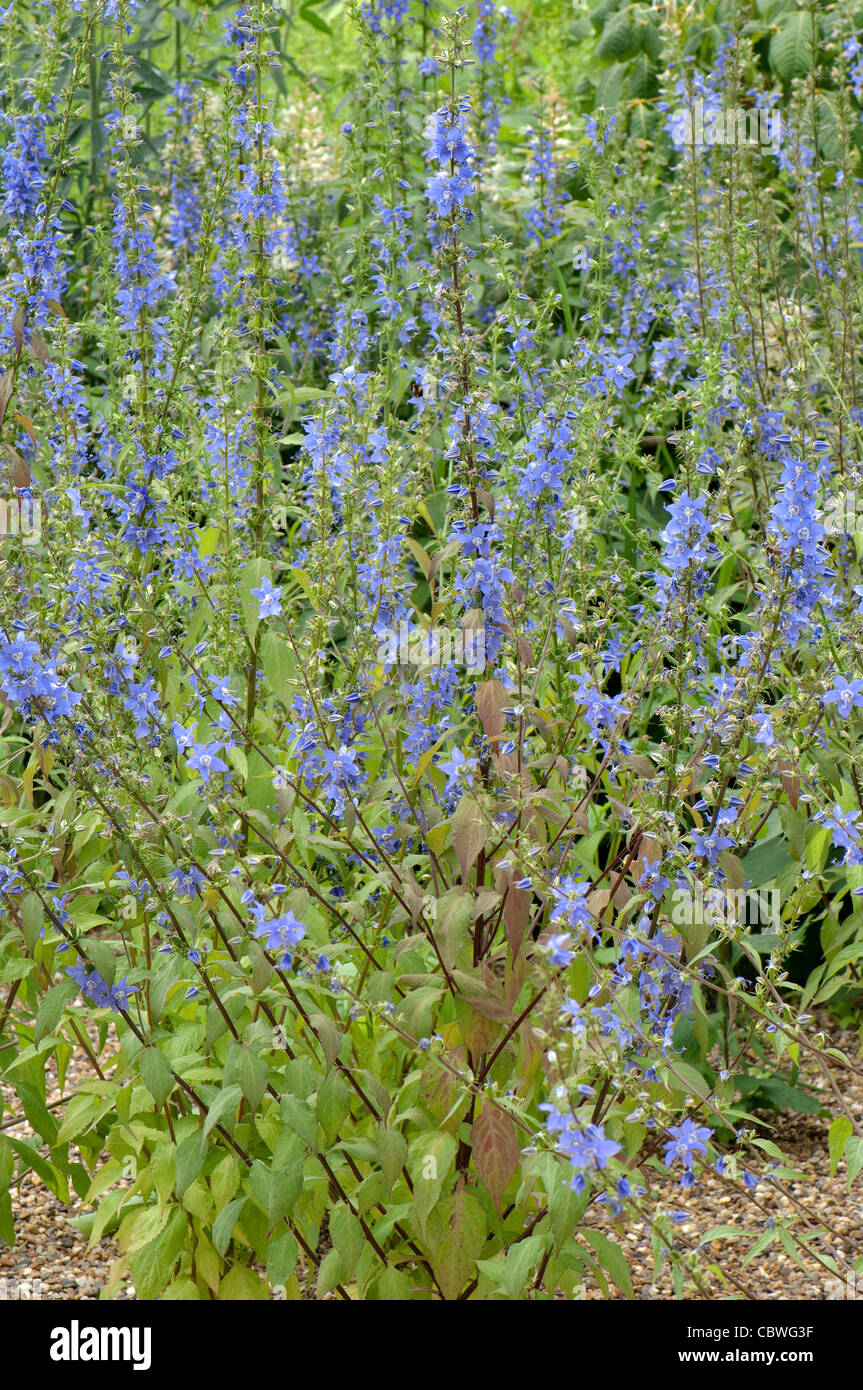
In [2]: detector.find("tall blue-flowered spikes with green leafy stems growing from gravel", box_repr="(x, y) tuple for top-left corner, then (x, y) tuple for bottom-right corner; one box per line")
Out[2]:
(0, 0), (863, 1300)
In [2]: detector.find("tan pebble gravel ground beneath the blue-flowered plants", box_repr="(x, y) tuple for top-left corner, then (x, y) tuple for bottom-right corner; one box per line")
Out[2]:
(0, 1031), (863, 1301)
